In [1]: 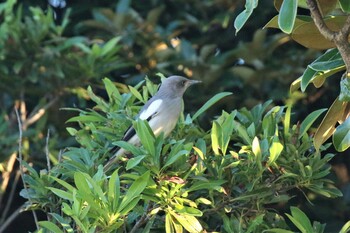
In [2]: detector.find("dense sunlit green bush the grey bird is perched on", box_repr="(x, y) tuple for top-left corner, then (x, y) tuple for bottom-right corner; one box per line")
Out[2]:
(22, 79), (341, 232)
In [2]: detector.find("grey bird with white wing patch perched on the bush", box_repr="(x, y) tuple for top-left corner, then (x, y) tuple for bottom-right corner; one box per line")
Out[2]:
(104, 76), (201, 171)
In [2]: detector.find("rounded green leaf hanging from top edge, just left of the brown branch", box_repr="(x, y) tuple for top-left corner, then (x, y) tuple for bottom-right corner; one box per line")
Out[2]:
(278, 0), (298, 34)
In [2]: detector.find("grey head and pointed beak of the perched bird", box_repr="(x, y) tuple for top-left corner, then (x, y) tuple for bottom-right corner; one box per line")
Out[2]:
(159, 76), (201, 97)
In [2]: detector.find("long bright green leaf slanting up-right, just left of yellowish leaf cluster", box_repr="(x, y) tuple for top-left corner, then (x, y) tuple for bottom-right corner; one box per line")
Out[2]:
(118, 171), (150, 212)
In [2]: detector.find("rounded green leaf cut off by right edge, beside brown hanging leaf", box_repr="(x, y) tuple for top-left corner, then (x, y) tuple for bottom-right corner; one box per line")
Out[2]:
(333, 117), (350, 152)
